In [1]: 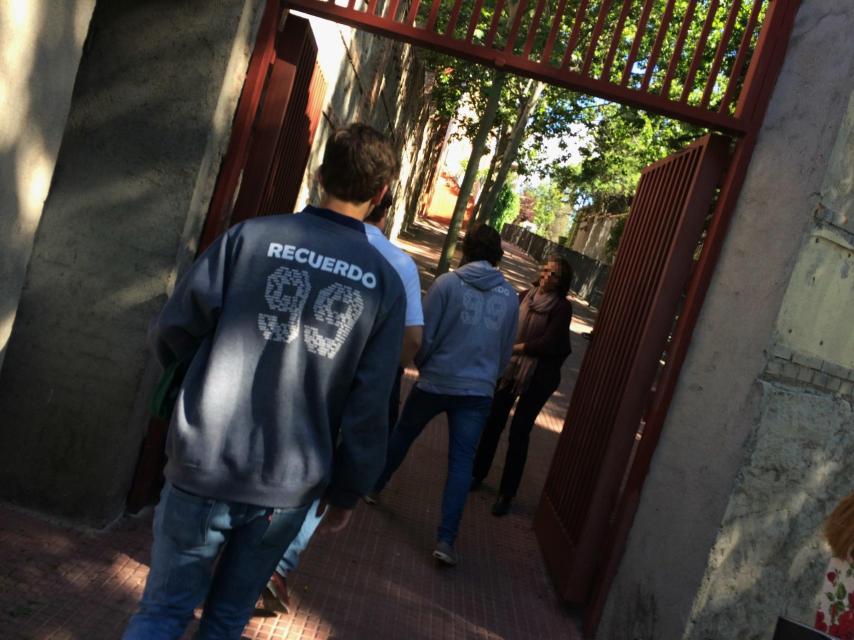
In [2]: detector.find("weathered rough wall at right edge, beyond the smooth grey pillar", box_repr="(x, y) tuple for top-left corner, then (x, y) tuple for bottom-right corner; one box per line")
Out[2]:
(685, 87), (854, 639)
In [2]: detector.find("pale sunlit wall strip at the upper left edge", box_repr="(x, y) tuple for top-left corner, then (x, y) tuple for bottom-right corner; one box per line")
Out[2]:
(0, 0), (95, 376)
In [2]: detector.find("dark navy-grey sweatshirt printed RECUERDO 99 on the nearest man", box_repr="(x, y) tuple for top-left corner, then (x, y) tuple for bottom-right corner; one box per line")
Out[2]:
(153, 207), (406, 507)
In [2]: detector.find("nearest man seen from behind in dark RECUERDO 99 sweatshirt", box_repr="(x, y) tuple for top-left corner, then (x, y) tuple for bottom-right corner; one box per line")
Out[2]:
(124, 125), (406, 640)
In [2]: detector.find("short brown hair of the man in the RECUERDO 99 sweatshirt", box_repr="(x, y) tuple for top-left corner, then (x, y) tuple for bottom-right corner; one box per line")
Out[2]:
(320, 123), (397, 203)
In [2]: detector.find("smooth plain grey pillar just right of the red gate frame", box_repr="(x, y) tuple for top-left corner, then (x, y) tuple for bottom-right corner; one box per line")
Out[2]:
(597, 0), (854, 640)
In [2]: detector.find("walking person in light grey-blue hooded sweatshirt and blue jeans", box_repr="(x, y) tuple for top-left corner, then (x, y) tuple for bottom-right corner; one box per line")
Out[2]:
(366, 225), (519, 565)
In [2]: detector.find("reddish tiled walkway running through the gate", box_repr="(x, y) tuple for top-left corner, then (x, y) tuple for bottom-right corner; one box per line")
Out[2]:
(0, 223), (593, 640)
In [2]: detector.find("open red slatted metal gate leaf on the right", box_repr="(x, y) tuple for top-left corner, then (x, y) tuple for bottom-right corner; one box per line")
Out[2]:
(534, 135), (729, 603)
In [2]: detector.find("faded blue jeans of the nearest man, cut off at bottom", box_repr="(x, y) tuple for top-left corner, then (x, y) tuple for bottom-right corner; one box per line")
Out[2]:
(123, 482), (306, 640)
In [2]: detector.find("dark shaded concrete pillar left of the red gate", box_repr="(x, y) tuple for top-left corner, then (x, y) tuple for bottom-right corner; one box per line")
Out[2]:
(0, 0), (262, 524)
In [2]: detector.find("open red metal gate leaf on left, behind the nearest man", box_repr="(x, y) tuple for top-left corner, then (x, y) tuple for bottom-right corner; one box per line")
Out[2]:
(127, 5), (326, 513)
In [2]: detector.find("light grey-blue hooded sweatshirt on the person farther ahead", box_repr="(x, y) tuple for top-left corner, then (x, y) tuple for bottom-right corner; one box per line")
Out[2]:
(415, 261), (519, 396)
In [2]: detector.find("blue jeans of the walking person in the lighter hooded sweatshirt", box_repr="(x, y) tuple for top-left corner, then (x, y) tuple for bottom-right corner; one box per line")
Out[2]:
(374, 386), (492, 544)
